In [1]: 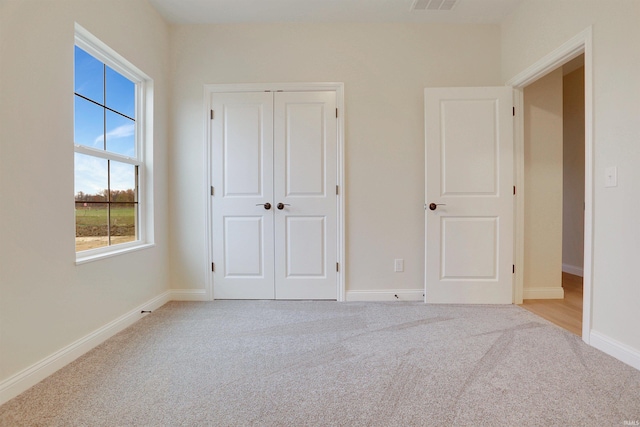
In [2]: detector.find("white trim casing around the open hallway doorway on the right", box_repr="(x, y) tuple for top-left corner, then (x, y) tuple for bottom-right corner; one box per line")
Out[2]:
(507, 27), (594, 344)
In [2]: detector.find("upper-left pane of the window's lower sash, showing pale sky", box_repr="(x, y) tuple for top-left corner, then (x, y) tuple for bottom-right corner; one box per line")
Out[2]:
(75, 153), (108, 202)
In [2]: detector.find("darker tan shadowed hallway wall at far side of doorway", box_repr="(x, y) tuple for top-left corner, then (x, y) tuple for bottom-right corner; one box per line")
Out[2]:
(562, 67), (584, 274)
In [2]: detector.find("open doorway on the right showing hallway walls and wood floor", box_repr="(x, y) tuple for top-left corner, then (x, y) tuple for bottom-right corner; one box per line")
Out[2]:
(523, 55), (584, 335)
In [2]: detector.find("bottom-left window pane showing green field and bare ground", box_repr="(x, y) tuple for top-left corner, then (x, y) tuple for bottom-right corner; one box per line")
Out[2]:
(76, 202), (109, 252)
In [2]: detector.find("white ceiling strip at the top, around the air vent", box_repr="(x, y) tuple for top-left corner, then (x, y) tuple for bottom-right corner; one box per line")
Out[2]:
(149, 0), (531, 24)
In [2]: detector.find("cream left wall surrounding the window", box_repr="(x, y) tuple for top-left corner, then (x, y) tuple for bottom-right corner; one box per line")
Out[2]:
(0, 0), (169, 389)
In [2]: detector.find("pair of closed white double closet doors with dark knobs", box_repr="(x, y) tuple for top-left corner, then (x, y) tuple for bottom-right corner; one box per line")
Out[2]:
(211, 91), (338, 299)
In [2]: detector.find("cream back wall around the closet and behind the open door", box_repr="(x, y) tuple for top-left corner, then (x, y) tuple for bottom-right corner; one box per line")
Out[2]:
(170, 24), (500, 297)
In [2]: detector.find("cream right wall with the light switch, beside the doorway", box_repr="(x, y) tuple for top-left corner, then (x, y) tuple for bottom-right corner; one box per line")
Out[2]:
(502, 0), (640, 354)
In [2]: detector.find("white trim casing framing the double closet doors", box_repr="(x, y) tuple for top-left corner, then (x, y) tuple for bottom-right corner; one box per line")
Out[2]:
(203, 82), (347, 301)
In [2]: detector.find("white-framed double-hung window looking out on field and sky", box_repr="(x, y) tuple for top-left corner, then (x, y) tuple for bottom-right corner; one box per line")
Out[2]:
(74, 27), (148, 259)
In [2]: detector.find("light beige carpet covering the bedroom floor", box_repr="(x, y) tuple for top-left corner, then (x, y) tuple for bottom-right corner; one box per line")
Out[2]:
(0, 301), (640, 427)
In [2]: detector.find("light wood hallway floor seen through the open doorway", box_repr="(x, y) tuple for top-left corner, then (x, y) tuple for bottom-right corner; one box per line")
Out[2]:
(521, 273), (582, 336)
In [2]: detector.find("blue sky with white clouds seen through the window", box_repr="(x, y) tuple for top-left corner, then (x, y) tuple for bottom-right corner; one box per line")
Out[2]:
(74, 46), (136, 194)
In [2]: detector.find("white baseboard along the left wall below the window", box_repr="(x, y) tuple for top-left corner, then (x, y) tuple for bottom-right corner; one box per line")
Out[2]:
(0, 291), (171, 405)
